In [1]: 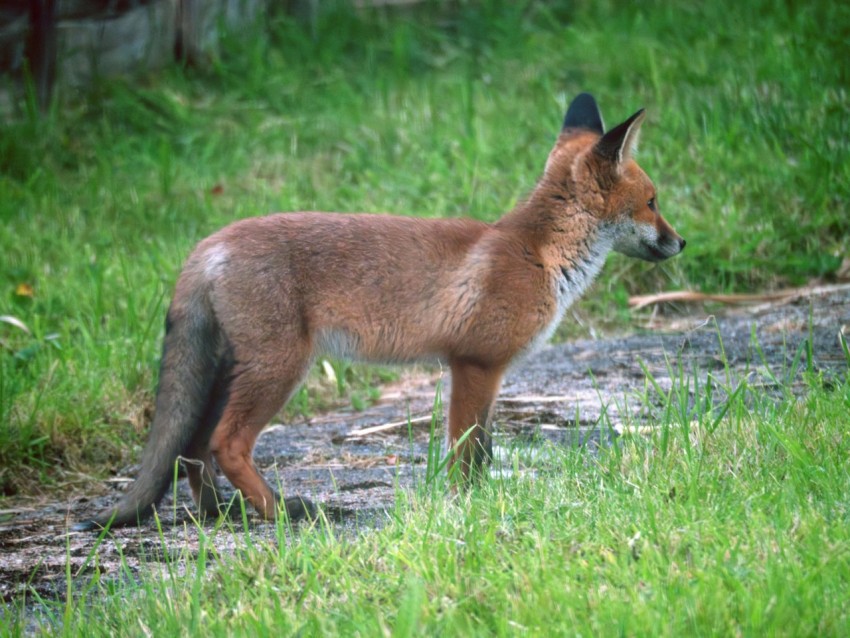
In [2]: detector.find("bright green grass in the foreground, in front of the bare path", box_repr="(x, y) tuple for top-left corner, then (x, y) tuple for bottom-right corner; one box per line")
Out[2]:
(0, 358), (850, 636)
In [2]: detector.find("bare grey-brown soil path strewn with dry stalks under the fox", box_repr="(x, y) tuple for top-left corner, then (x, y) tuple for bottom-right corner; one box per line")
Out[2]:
(0, 285), (850, 611)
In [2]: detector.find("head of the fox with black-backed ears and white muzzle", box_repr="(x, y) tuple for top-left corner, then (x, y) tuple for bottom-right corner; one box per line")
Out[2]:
(544, 93), (685, 262)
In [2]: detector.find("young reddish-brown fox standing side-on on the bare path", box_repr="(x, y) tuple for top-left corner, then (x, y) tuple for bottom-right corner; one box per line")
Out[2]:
(71, 93), (685, 530)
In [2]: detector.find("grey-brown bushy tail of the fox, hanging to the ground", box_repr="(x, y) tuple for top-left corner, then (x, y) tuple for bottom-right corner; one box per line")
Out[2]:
(74, 293), (222, 531)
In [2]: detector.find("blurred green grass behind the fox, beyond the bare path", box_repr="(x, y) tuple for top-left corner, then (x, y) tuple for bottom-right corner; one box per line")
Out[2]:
(0, 0), (850, 495)
